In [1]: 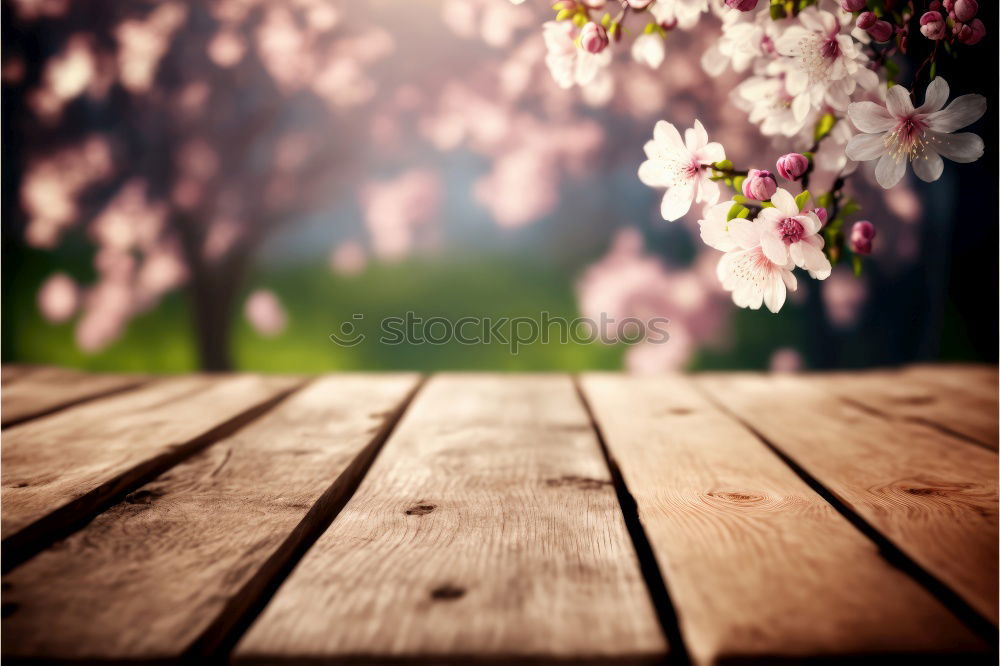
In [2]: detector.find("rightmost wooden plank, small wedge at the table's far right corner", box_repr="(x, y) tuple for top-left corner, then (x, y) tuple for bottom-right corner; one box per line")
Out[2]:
(812, 367), (1000, 450)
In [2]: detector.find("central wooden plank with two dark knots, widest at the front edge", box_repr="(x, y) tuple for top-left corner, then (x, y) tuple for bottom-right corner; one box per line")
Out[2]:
(237, 375), (666, 663)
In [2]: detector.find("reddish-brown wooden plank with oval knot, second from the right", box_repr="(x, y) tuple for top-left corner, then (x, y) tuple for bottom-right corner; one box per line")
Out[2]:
(697, 375), (998, 624)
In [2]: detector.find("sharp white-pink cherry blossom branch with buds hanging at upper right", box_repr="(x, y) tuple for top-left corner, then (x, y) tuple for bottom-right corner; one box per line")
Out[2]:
(512, 0), (986, 312)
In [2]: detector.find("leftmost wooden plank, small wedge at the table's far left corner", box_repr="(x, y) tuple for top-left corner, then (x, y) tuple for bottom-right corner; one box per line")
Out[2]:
(0, 366), (149, 428)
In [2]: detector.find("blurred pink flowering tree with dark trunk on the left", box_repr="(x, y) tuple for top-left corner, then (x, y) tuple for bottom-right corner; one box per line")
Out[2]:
(3, 0), (393, 370)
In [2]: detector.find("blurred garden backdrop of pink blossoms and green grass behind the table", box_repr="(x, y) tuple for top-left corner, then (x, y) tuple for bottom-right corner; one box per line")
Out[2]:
(2, 0), (998, 372)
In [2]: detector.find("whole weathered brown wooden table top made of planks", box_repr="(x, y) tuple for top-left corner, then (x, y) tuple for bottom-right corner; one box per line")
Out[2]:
(2, 366), (998, 664)
